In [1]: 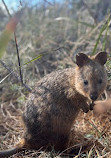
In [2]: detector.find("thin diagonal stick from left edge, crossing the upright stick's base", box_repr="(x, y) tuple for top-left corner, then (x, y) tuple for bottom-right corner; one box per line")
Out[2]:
(0, 60), (32, 92)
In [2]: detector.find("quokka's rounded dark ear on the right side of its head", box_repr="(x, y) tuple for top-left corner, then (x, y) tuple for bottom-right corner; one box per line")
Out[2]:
(95, 52), (107, 65)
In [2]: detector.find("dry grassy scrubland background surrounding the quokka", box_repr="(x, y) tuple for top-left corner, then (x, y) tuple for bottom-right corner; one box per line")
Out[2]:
(0, 0), (111, 158)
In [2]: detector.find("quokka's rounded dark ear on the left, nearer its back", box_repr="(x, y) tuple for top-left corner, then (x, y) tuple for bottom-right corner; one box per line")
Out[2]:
(76, 53), (90, 67)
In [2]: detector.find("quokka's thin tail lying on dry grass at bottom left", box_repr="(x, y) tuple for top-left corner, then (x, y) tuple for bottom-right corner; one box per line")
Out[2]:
(0, 139), (26, 158)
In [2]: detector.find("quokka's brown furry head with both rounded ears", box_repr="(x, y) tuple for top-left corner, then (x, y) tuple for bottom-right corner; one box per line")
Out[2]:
(75, 52), (107, 101)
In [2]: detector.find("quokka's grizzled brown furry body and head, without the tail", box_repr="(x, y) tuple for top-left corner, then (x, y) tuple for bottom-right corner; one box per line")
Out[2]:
(0, 52), (107, 158)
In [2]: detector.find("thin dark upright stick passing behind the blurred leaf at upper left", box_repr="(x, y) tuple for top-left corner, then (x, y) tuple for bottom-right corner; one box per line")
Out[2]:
(2, 0), (24, 85)
